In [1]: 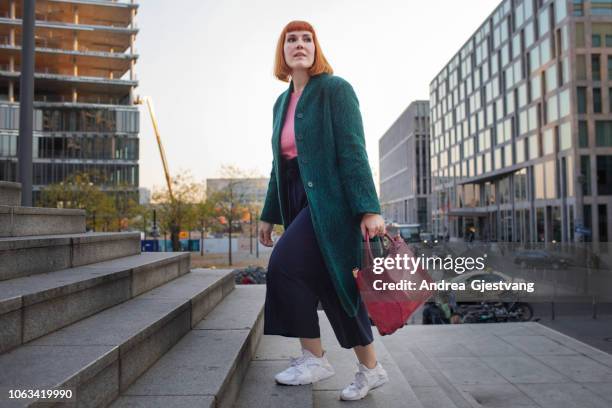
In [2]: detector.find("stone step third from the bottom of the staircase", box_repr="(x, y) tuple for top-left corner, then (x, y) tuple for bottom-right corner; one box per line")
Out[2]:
(0, 252), (190, 353)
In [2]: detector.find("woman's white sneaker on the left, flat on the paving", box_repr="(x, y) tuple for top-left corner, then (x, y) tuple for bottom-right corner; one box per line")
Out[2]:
(274, 349), (335, 385)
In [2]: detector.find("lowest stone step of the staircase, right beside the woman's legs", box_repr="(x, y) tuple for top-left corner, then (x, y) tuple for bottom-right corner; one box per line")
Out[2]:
(111, 285), (265, 408)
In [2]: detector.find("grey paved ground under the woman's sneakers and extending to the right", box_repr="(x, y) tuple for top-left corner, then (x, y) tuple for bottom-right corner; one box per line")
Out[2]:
(238, 314), (612, 408)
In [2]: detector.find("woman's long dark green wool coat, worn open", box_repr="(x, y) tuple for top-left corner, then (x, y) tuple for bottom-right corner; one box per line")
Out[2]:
(260, 74), (380, 316)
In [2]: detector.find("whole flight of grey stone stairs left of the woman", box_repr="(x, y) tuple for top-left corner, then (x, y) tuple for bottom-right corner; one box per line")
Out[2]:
(0, 183), (264, 407)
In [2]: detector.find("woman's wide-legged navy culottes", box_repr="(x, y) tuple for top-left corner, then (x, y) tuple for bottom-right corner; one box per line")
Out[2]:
(264, 159), (373, 348)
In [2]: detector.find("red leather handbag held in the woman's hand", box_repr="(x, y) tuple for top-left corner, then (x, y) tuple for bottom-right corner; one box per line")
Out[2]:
(354, 232), (433, 336)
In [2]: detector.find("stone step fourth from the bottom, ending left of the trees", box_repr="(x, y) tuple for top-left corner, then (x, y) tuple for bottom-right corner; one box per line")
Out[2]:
(0, 232), (140, 281)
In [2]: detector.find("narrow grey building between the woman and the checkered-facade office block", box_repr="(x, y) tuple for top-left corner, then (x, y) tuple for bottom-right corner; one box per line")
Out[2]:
(378, 101), (431, 231)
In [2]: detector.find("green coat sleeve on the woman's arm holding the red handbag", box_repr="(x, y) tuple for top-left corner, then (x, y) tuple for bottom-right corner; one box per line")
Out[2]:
(331, 78), (380, 220)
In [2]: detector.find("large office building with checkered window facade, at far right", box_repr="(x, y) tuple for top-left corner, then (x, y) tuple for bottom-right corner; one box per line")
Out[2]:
(430, 0), (612, 242)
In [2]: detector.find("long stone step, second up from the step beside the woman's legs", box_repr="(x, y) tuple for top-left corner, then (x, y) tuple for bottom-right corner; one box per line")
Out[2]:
(0, 269), (234, 407)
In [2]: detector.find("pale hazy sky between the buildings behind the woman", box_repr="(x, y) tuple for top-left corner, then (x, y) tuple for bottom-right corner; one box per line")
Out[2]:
(136, 0), (500, 190)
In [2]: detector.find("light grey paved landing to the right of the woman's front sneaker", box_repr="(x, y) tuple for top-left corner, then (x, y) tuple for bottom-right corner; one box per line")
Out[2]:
(383, 322), (612, 408)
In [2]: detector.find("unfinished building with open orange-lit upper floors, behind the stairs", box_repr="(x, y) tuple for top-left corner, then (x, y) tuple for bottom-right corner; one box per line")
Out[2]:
(0, 0), (139, 203)
